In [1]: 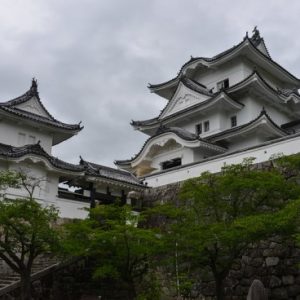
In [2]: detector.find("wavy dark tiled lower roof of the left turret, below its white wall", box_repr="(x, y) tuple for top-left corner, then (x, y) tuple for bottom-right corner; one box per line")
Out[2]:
(0, 143), (84, 172)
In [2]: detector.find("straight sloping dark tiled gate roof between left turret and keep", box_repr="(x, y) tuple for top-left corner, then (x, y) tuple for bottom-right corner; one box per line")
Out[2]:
(80, 157), (143, 187)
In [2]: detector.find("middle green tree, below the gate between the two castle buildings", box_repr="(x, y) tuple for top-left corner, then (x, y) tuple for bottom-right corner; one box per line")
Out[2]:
(65, 204), (160, 299)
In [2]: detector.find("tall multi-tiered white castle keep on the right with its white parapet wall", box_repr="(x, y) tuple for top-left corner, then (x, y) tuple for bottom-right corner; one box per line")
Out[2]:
(115, 28), (300, 187)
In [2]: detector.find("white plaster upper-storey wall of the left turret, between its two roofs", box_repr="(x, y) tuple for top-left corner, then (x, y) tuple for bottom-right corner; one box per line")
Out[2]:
(0, 119), (53, 154)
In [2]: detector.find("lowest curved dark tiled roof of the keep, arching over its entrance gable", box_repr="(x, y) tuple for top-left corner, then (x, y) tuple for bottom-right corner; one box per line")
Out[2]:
(115, 126), (224, 165)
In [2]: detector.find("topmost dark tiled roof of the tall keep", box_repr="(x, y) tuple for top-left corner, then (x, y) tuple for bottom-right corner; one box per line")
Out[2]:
(148, 33), (299, 89)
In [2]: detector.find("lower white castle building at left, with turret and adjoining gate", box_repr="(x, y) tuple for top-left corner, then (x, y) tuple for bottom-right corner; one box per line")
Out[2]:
(0, 80), (145, 218)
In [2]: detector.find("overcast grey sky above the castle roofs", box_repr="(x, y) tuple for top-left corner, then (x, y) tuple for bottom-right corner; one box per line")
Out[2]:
(0, 0), (300, 166)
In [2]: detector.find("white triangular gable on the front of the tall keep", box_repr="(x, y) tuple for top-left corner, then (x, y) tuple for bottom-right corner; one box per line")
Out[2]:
(160, 83), (210, 119)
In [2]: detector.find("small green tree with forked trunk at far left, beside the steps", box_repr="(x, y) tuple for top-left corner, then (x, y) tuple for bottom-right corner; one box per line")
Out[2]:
(0, 199), (59, 300)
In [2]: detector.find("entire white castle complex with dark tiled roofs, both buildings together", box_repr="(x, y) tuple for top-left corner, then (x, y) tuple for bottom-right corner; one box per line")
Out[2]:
(0, 28), (300, 218)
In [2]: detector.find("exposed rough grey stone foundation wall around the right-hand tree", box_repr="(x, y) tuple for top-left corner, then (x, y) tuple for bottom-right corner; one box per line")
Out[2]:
(143, 183), (300, 300)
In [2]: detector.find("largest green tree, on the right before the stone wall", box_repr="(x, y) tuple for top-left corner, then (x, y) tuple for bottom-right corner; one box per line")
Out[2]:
(155, 159), (300, 300)
